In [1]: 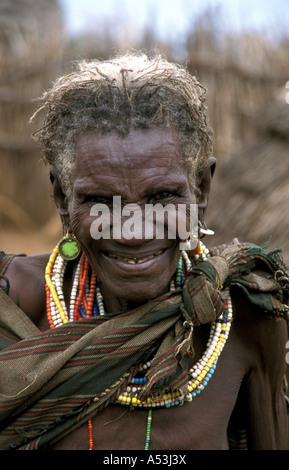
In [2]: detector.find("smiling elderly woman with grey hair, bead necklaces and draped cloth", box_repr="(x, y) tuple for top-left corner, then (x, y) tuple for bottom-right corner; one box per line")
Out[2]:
(0, 54), (289, 450)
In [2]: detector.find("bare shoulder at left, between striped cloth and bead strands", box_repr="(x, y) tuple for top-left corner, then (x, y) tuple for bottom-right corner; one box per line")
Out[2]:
(5, 254), (49, 325)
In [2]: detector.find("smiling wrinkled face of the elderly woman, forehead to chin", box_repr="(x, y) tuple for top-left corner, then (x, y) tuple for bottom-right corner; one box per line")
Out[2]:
(68, 128), (196, 303)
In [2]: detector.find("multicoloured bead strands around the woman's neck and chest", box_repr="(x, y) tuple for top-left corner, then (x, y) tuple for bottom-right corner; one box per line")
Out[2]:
(45, 242), (232, 450)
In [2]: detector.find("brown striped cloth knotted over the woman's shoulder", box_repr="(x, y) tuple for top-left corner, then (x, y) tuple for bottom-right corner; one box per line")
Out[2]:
(0, 244), (289, 449)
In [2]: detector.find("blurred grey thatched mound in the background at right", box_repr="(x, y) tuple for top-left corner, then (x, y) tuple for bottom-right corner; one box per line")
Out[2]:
(207, 101), (289, 263)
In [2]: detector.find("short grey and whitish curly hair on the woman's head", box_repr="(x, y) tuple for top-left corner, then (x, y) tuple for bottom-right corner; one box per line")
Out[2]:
(31, 53), (213, 196)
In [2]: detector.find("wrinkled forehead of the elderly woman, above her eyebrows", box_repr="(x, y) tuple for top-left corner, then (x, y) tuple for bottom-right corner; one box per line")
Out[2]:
(75, 127), (183, 175)
